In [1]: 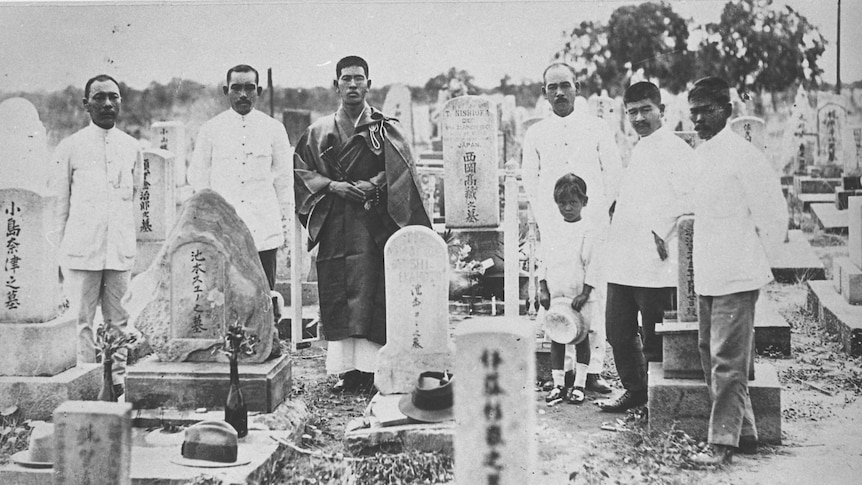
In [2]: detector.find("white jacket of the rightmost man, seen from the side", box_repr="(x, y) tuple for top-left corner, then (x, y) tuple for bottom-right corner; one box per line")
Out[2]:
(693, 127), (787, 296)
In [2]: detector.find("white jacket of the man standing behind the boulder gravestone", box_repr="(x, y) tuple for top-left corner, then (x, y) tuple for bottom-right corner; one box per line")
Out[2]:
(188, 109), (293, 251)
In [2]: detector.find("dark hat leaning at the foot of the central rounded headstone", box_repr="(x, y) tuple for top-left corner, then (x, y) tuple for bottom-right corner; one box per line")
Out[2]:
(398, 371), (452, 423)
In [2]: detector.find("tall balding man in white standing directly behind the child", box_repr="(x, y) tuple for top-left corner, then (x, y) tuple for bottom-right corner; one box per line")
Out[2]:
(522, 62), (622, 394)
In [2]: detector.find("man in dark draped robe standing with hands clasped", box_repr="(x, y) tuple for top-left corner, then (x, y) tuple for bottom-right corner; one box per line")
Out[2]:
(294, 56), (431, 390)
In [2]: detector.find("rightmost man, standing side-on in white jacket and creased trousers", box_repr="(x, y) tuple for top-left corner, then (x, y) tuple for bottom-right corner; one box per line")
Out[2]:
(688, 77), (787, 465)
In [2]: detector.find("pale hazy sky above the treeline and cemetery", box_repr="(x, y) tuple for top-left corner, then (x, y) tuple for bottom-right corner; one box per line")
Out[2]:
(0, 0), (862, 92)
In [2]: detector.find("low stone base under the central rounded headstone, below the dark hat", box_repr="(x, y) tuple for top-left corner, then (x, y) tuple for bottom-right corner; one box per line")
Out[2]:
(344, 393), (455, 456)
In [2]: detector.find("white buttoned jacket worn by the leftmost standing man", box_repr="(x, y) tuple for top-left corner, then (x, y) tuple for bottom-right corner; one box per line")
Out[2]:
(52, 123), (141, 271)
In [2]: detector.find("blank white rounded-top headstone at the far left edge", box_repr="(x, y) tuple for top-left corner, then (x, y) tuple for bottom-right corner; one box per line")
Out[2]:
(0, 98), (49, 195)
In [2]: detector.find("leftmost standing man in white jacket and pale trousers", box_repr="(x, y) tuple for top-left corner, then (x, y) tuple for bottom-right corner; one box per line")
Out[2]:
(52, 74), (142, 394)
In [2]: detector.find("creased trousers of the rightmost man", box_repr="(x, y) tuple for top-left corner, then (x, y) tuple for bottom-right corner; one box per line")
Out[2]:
(697, 290), (759, 446)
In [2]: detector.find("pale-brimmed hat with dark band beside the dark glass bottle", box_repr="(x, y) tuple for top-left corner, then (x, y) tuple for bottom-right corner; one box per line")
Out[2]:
(171, 420), (251, 468)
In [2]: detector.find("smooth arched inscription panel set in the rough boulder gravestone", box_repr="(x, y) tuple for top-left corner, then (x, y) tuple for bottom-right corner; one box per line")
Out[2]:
(171, 242), (226, 339)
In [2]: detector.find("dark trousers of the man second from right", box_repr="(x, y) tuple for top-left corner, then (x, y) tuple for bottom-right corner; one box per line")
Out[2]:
(605, 283), (674, 391)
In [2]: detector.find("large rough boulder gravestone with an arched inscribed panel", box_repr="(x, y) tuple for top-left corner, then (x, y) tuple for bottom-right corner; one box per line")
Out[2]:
(124, 190), (273, 363)
